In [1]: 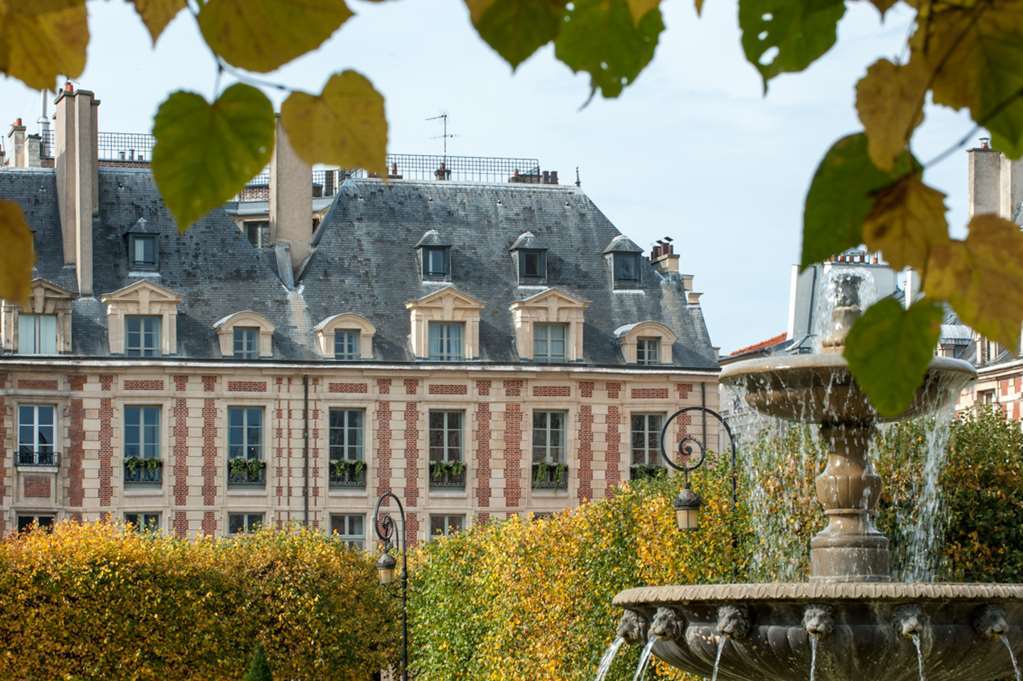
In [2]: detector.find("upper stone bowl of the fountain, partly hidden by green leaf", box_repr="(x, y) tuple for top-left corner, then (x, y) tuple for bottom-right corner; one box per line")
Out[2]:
(721, 353), (977, 423)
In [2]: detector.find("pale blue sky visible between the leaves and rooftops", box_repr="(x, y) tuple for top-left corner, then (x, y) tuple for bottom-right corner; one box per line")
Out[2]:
(0, 0), (974, 353)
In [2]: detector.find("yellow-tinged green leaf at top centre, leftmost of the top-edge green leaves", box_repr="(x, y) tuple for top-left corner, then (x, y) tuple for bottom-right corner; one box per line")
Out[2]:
(465, 0), (566, 69)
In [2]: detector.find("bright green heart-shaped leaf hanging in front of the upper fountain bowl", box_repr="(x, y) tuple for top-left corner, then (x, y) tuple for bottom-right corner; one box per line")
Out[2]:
(844, 298), (944, 416)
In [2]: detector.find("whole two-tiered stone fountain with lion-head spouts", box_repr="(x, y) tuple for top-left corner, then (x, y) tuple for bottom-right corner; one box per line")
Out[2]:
(615, 275), (1023, 681)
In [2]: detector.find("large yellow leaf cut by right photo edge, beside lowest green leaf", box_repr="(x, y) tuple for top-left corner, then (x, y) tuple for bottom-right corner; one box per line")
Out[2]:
(924, 214), (1023, 348)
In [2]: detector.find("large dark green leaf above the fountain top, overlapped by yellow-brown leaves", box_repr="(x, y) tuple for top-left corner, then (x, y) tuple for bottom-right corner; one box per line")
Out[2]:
(800, 133), (916, 268)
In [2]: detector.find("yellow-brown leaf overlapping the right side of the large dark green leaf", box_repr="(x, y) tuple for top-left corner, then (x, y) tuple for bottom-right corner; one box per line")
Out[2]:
(863, 173), (948, 270)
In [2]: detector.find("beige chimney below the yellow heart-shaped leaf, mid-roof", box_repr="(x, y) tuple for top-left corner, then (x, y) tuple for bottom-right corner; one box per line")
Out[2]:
(270, 116), (313, 274)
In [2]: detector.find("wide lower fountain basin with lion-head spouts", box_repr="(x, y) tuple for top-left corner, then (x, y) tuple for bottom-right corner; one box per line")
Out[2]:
(614, 582), (1023, 681)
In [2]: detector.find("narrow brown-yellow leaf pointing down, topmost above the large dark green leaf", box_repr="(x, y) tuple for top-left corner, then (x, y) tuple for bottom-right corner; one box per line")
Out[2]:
(856, 59), (928, 171)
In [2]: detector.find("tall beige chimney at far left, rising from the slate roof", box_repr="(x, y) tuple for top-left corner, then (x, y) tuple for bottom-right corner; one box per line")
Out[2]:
(53, 83), (99, 298)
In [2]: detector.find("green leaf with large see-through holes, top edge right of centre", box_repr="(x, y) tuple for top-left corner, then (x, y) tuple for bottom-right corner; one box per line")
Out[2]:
(739, 0), (845, 92)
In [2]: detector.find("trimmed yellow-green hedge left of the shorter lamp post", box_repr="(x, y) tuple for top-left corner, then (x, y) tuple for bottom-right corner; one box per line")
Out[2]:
(0, 523), (398, 681)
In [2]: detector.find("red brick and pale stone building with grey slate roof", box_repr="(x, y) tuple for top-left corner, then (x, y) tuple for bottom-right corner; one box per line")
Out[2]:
(0, 90), (718, 543)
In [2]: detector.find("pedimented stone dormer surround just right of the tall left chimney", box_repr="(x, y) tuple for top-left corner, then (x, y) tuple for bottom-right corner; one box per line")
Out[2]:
(99, 281), (181, 355)
